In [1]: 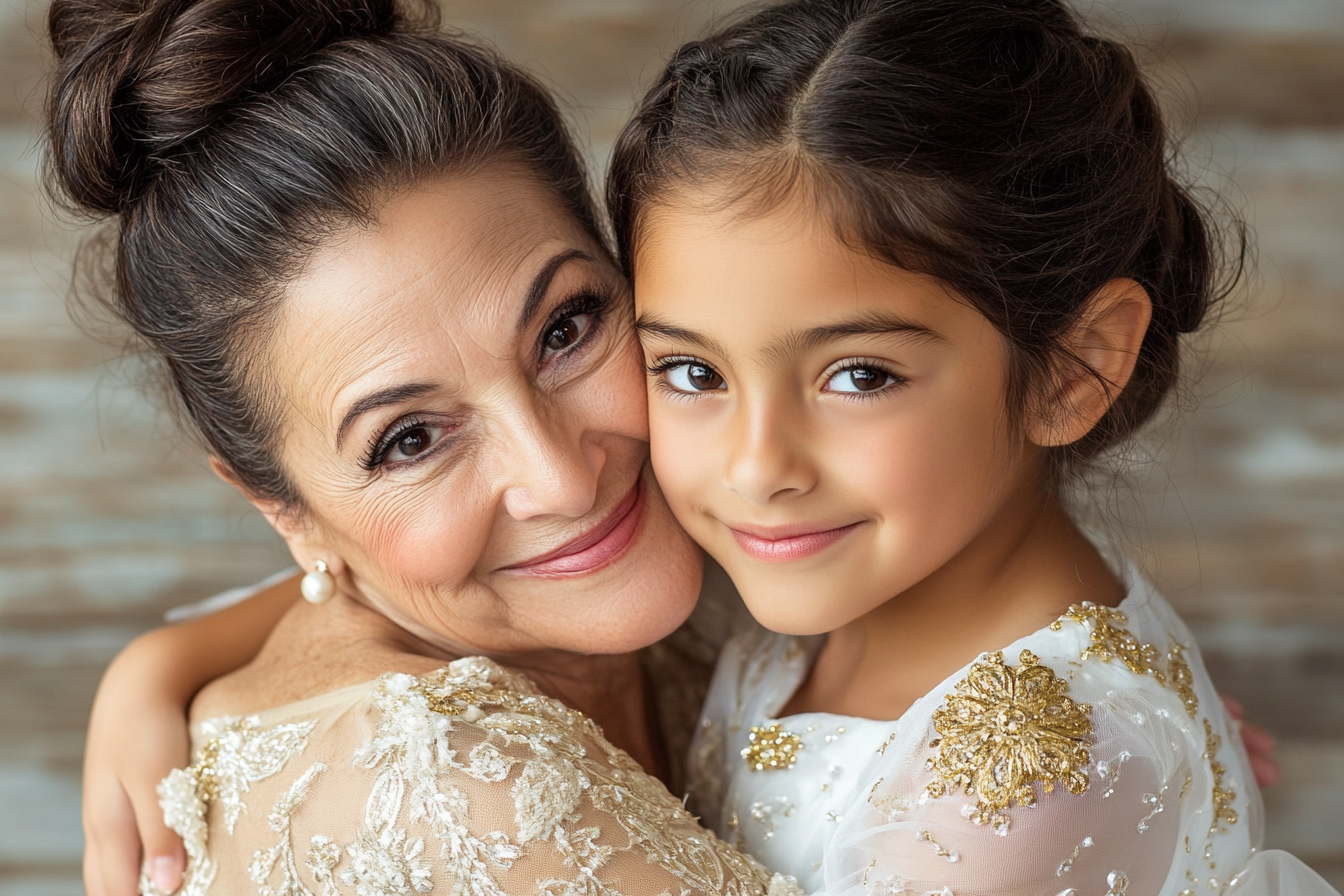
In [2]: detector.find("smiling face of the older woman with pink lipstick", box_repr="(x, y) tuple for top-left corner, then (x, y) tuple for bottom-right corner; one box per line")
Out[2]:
(259, 165), (700, 654)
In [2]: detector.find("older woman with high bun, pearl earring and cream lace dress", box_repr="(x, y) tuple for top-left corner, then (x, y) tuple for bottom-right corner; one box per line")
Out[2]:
(48, 0), (786, 895)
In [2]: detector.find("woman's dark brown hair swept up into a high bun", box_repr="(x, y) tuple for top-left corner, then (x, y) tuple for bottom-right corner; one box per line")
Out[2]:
(47, 0), (598, 508)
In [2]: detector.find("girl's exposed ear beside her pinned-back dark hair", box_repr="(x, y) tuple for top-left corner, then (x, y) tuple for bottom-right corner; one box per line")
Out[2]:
(1030, 277), (1153, 447)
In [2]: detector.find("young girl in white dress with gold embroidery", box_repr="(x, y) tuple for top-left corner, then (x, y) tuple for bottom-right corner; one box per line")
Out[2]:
(610, 0), (1333, 896)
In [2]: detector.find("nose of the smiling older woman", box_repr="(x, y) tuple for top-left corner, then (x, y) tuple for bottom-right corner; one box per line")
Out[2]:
(496, 405), (606, 520)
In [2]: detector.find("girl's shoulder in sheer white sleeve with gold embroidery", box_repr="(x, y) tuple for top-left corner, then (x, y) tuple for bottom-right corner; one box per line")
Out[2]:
(827, 585), (1259, 893)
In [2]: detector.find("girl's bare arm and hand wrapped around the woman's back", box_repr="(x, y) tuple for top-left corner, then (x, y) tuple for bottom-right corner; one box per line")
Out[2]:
(83, 574), (298, 896)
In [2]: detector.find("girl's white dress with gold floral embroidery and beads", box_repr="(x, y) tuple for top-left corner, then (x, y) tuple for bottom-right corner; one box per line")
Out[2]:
(691, 570), (1337, 896)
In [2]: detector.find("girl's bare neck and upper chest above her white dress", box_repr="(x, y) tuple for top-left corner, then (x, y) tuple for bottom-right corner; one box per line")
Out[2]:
(784, 489), (1125, 719)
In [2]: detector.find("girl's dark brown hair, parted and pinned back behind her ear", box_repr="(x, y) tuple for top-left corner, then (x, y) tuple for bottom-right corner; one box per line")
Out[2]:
(607, 0), (1241, 473)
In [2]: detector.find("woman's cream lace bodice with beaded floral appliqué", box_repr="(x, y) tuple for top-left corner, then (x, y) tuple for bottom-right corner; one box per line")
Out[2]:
(142, 658), (797, 896)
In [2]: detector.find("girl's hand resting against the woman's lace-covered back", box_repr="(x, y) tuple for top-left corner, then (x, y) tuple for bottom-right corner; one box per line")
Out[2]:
(83, 630), (190, 896)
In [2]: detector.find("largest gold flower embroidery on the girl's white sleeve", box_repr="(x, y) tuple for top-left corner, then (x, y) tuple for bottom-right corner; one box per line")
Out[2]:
(926, 650), (1093, 830)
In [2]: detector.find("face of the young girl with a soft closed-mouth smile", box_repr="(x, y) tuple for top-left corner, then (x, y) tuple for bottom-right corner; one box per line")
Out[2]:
(634, 191), (1040, 634)
